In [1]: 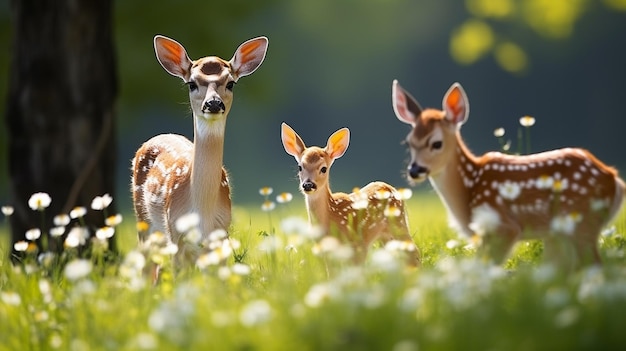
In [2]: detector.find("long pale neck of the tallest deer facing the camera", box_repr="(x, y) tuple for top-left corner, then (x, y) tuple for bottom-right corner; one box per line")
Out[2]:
(190, 116), (226, 226)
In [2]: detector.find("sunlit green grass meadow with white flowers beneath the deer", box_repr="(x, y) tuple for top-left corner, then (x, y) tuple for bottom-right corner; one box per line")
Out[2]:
(0, 194), (626, 351)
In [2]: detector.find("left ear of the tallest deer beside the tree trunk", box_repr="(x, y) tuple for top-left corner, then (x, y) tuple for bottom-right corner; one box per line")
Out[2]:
(154, 35), (191, 81)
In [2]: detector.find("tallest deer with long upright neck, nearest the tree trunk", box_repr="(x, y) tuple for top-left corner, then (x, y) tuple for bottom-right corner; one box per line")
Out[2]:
(131, 35), (268, 278)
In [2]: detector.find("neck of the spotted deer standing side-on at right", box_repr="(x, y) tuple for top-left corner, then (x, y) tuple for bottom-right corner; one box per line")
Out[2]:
(430, 135), (478, 234)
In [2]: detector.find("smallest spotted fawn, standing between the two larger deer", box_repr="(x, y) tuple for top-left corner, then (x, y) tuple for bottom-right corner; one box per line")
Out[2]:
(281, 122), (420, 266)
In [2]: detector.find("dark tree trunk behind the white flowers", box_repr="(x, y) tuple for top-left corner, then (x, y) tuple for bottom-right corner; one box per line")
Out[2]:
(5, 0), (118, 261)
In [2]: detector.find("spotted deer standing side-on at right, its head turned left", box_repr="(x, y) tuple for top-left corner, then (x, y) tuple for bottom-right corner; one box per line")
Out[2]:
(392, 80), (624, 270)
